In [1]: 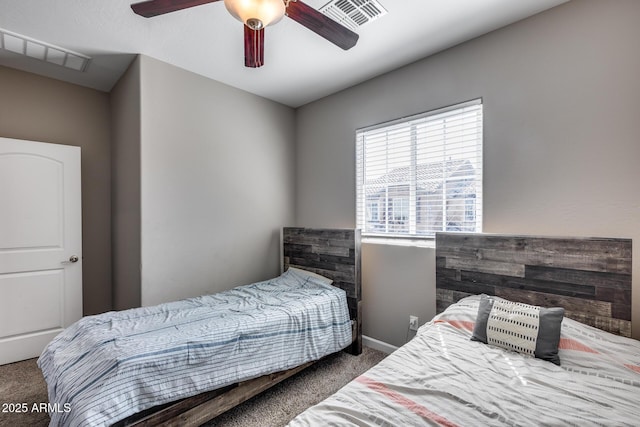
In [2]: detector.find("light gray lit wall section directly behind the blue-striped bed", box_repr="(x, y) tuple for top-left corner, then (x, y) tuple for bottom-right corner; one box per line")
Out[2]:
(140, 56), (295, 305)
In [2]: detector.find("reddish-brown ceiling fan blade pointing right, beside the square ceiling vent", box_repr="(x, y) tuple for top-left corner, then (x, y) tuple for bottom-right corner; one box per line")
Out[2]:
(285, 0), (360, 50)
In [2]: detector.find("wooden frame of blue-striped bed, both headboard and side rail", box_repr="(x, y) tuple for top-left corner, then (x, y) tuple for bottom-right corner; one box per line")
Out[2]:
(113, 227), (362, 427)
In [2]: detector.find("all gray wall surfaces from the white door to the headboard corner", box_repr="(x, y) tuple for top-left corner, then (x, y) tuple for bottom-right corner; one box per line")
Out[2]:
(0, 52), (295, 315)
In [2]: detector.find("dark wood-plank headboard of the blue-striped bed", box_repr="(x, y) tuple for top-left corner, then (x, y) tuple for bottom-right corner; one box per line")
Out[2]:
(282, 227), (362, 354)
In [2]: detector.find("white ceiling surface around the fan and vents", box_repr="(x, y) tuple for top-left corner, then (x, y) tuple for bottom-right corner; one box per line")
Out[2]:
(0, 0), (567, 107)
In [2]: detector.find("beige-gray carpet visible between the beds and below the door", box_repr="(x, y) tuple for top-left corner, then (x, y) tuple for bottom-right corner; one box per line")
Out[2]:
(0, 347), (386, 427)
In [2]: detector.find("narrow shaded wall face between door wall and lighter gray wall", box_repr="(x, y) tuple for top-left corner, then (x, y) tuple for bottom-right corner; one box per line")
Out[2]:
(110, 57), (141, 310)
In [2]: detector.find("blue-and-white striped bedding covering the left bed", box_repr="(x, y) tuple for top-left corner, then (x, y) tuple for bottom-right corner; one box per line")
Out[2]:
(38, 269), (352, 426)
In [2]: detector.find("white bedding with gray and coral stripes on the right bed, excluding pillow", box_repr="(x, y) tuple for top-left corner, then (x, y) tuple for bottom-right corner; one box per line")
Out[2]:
(289, 296), (640, 427)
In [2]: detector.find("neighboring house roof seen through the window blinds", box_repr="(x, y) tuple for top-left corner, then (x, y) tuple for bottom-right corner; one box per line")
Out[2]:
(365, 160), (474, 196)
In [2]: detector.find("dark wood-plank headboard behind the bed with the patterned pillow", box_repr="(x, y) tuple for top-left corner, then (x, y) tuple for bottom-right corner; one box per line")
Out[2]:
(436, 233), (631, 337)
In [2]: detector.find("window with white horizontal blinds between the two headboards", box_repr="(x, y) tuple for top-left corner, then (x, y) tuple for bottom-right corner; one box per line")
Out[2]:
(356, 99), (482, 239)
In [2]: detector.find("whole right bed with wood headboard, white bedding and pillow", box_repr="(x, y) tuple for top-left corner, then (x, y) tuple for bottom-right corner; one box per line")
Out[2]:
(289, 233), (640, 427)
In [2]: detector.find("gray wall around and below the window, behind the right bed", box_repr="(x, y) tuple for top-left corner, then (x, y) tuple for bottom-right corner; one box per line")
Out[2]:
(296, 0), (640, 345)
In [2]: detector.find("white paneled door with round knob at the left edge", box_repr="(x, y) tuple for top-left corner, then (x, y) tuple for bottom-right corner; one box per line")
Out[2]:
(0, 137), (82, 364)
